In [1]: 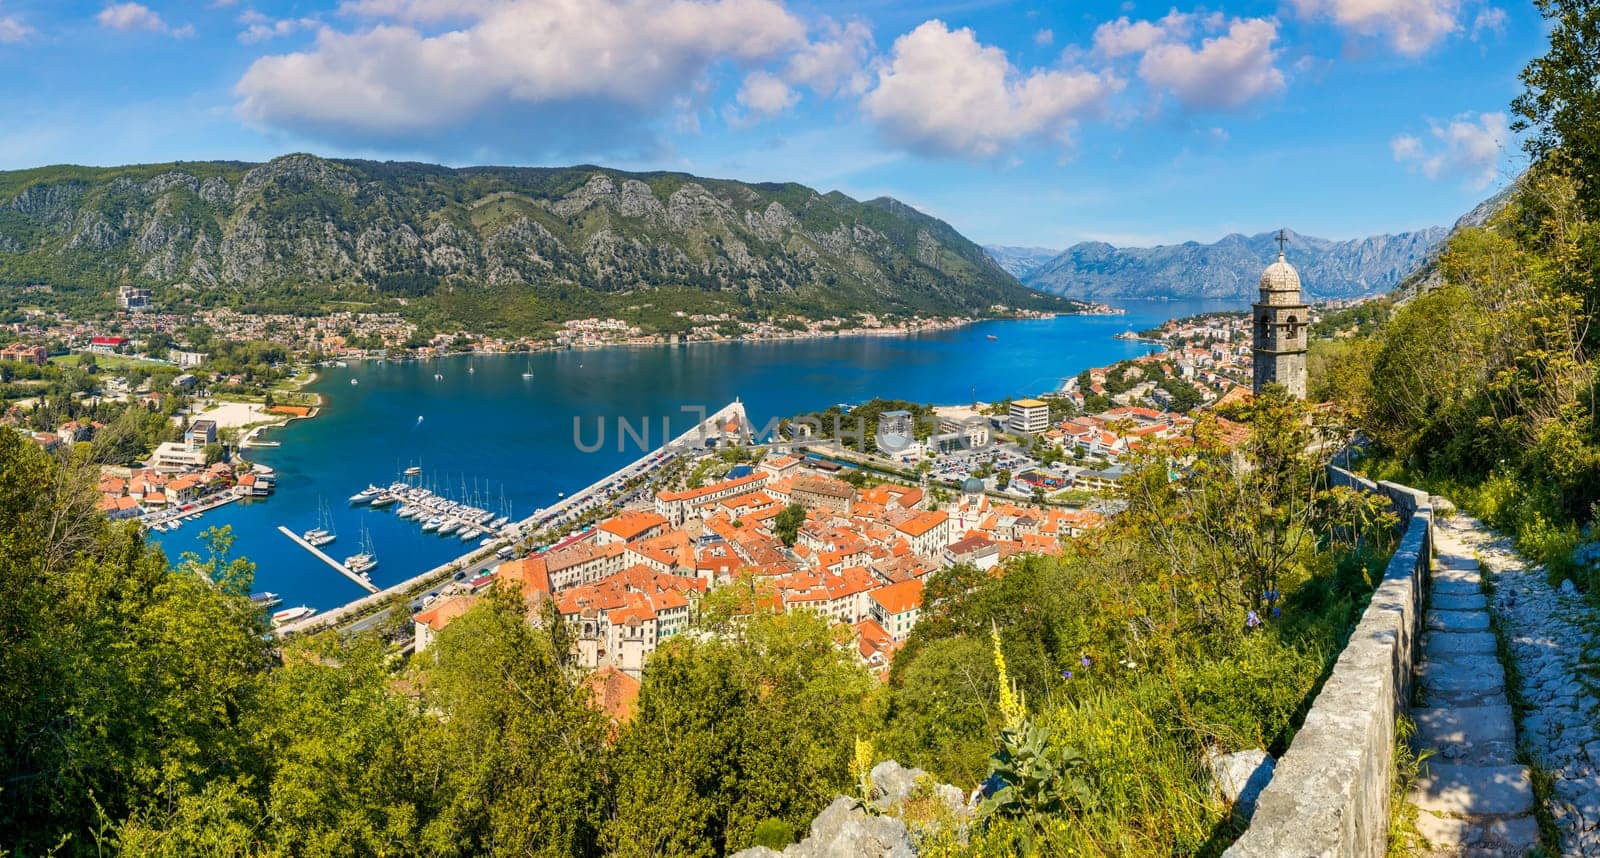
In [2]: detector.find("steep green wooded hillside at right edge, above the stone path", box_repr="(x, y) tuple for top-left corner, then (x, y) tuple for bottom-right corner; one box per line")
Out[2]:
(1314, 0), (1600, 591)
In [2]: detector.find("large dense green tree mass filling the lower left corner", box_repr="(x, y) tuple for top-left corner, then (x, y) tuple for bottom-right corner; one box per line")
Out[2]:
(0, 432), (267, 855)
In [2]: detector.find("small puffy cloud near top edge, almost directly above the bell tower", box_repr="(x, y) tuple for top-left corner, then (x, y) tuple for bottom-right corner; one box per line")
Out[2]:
(1139, 18), (1283, 109)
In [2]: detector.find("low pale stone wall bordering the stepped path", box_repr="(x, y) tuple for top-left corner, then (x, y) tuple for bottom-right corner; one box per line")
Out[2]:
(1226, 467), (1434, 858)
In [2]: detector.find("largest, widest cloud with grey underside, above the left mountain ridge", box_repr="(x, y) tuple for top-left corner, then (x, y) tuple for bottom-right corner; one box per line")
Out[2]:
(235, 0), (805, 150)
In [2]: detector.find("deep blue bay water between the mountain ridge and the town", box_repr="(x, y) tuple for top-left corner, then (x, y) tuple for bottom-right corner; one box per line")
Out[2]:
(155, 303), (1237, 610)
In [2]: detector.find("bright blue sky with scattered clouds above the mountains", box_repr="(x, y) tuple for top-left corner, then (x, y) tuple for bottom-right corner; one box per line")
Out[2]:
(0, 0), (1547, 248)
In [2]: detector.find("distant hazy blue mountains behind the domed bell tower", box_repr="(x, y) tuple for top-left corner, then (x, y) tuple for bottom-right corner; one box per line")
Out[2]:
(986, 227), (1448, 299)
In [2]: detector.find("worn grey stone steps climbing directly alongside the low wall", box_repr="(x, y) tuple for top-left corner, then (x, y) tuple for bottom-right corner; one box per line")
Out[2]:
(1411, 528), (1539, 858)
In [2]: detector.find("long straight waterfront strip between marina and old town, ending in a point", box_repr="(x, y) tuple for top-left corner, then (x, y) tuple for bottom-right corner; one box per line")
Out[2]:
(274, 400), (747, 637)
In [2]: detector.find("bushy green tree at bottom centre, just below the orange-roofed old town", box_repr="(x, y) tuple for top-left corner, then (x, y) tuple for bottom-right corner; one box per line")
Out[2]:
(605, 611), (877, 856)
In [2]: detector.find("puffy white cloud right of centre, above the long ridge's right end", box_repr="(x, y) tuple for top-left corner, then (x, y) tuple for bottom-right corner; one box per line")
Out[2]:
(861, 19), (1120, 158)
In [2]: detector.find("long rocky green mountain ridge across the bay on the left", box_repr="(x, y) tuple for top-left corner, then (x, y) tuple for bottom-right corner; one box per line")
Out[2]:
(0, 154), (1070, 330)
